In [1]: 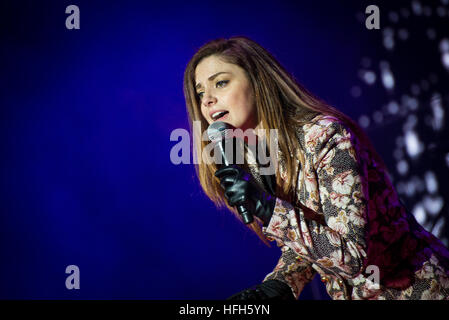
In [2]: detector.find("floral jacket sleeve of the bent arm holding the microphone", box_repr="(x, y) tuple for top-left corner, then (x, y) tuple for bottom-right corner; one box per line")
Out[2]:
(265, 122), (368, 278)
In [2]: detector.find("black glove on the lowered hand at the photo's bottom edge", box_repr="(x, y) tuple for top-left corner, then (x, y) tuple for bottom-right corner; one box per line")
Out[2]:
(227, 280), (296, 300)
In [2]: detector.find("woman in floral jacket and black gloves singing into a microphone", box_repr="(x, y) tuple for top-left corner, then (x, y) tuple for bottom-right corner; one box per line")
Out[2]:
(184, 37), (449, 299)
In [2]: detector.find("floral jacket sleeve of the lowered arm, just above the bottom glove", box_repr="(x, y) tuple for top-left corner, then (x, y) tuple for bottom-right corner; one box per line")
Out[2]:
(263, 241), (316, 299)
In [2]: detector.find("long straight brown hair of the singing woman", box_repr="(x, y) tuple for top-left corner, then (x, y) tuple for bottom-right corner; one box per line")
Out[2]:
(184, 36), (384, 245)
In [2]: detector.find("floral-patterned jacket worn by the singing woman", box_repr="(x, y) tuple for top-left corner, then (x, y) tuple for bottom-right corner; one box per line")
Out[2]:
(262, 115), (449, 299)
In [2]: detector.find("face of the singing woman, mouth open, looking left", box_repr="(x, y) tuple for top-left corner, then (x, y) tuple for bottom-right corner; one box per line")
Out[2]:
(195, 56), (257, 131)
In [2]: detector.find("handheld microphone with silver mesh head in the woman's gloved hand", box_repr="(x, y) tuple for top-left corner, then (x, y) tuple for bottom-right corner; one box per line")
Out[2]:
(207, 121), (254, 224)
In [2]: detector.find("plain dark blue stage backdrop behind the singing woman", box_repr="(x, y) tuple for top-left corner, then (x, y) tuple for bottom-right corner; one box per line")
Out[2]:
(0, 0), (446, 299)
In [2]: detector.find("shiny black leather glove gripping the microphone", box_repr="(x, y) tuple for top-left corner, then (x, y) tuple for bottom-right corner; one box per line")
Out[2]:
(215, 165), (276, 227)
